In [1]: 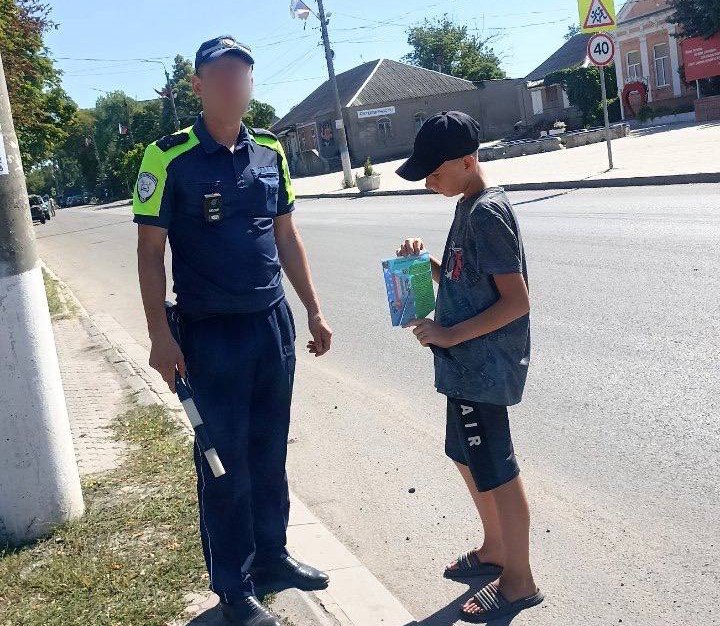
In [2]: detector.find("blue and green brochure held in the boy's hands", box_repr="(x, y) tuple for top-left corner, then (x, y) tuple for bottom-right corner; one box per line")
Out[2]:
(382, 252), (435, 326)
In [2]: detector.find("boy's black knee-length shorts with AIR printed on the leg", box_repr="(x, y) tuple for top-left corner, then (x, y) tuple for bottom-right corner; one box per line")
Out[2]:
(445, 398), (520, 491)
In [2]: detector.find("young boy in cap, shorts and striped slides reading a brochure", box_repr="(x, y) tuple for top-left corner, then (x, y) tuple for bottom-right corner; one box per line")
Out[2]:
(397, 111), (544, 622)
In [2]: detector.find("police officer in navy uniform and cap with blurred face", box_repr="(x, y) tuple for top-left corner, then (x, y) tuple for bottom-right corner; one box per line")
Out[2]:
(133, 36), (332, 626)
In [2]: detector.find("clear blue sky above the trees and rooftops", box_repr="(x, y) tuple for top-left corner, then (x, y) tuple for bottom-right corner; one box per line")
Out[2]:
(46, 0), (578, 116)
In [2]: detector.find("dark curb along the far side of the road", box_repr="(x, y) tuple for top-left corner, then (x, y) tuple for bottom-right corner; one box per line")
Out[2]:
(296, 172), (720, 200)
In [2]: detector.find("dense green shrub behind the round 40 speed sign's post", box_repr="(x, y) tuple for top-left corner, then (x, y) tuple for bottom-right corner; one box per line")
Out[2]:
(545, 64), (618, 126)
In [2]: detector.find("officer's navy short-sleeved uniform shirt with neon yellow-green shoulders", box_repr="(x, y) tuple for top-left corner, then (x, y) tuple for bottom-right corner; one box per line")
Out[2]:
(133, 116), (294, 317)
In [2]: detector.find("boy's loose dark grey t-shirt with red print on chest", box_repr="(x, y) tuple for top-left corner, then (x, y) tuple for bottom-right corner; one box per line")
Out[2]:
(433, 187), (530, 406)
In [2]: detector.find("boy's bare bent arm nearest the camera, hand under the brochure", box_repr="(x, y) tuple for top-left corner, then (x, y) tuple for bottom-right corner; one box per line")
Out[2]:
(407, 274), (530, 348)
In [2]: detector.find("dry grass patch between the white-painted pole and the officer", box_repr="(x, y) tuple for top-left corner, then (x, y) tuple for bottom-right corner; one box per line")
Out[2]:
(0, 402), (207, 626)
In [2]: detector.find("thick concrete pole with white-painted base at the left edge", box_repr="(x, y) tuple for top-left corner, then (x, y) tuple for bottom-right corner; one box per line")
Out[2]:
(0, 50), (84, 545)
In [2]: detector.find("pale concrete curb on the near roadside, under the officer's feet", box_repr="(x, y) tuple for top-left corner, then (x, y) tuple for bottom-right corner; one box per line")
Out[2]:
(41, 261), (417, 626)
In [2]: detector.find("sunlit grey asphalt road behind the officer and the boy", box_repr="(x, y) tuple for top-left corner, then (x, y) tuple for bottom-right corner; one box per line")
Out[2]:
(37, 185), (720, 626)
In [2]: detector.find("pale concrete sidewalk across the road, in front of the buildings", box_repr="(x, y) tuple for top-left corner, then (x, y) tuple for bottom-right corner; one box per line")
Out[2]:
(293, 122), (720, 198)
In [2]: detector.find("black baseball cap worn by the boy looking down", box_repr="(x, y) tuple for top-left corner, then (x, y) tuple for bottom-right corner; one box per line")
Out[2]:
(397, 111), (481, 181)
